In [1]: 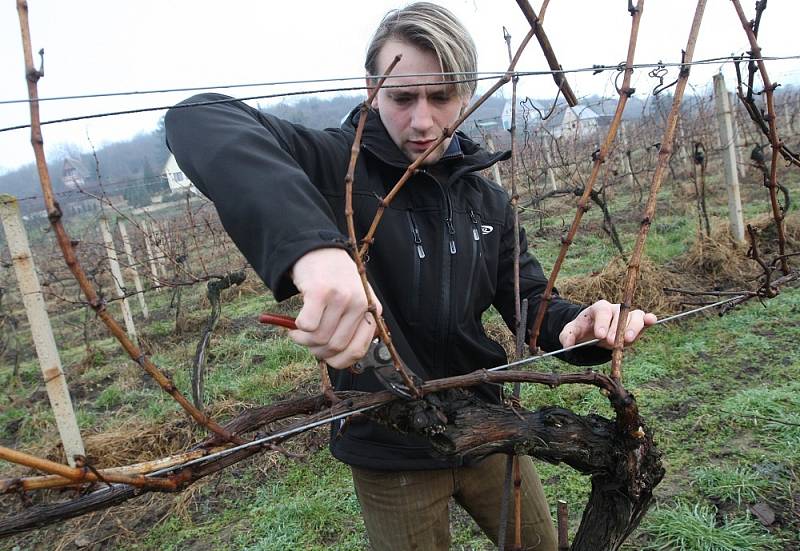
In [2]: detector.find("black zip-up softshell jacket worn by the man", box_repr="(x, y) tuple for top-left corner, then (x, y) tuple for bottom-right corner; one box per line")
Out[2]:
(165, 94), (609, 469)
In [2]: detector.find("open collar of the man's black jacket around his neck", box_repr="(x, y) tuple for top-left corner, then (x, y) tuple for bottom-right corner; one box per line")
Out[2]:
(342, 106), (511, 180)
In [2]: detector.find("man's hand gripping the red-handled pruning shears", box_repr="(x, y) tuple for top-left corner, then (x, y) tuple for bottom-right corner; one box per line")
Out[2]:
(289, 248), (382, 369)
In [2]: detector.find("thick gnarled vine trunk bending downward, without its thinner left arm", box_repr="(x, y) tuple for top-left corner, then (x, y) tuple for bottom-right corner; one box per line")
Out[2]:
(371, 391), (664, 551)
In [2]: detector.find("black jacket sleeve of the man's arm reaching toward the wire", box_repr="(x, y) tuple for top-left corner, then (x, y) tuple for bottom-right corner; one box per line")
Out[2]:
(494, 199), (611, 365)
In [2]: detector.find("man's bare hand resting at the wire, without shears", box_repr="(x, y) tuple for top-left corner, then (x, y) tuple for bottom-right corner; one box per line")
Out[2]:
(558, 300), (658, 349)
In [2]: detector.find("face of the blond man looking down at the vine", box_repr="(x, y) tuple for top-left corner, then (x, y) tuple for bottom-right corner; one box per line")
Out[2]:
(372, 39), (469, 164)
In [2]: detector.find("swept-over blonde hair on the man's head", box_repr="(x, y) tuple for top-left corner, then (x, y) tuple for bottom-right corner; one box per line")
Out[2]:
(364, 2), (478, 98)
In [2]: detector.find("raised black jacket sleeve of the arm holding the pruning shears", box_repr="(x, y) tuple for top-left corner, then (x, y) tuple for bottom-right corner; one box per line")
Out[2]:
(165, 94), (350, 300)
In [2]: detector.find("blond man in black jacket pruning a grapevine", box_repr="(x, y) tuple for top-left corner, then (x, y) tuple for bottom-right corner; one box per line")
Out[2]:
(166, 3), (655, 550)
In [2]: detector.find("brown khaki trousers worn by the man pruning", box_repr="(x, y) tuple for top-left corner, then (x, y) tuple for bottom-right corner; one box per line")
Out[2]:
(351, 454), (556, 551)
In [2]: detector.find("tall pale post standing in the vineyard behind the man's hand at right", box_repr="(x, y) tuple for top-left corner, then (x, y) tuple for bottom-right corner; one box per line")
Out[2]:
(714, 73), (744, 243)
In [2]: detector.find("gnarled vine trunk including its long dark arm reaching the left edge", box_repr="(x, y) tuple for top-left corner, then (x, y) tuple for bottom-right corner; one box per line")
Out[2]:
(0, 390), (664, 551)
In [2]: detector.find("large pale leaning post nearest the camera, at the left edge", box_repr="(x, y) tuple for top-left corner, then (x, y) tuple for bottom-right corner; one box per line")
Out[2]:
(0, 195), (86, 467)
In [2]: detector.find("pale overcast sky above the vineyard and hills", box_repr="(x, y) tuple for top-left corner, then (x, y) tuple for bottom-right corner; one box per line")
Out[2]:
(0, 0), (800, 177)
